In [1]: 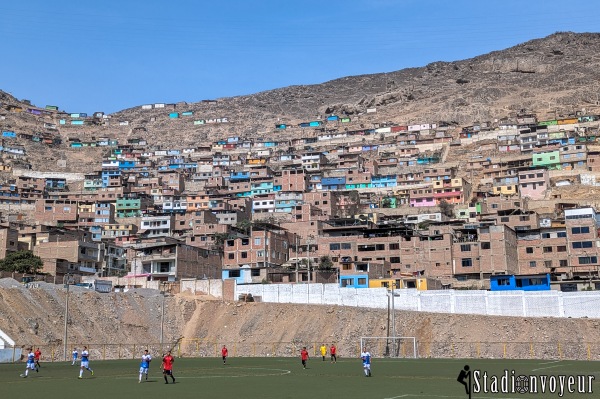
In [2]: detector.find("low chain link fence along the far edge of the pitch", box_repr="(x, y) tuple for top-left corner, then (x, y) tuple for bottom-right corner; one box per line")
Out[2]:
(4, 339), (600, 362)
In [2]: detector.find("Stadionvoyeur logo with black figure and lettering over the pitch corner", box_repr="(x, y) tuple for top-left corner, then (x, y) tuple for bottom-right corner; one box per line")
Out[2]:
(456, 365), (596, 399)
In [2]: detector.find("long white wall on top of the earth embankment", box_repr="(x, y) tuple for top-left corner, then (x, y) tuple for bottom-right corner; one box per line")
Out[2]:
(235, 284), (600, 318)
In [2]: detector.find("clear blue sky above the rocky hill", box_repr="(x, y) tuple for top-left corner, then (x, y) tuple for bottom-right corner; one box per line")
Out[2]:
(0, 0), (600, 113)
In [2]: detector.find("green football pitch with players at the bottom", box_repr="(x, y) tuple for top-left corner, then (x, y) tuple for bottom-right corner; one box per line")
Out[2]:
(0, 358), (600, 399)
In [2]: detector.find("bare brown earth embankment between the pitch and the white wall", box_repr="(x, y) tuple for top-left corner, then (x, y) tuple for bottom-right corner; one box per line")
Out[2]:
(0, 279), (600, 360)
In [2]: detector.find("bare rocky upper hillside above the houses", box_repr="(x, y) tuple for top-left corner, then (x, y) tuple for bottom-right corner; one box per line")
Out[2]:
(0, 32), (600, 171)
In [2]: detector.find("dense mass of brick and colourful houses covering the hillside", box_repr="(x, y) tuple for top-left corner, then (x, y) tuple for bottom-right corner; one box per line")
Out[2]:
(0, 105), (600, 287)
